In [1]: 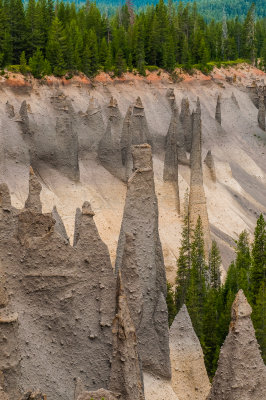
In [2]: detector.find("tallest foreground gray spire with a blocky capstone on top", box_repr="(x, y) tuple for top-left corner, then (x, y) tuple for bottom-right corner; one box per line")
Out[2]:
(116, 144), (171, 378)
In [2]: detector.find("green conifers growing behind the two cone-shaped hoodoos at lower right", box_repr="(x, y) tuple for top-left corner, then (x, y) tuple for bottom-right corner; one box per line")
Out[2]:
(167, 203), (266, 378)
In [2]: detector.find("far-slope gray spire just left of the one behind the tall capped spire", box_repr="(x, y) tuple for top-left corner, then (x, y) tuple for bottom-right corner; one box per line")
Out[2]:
(98, 97), (125, 180)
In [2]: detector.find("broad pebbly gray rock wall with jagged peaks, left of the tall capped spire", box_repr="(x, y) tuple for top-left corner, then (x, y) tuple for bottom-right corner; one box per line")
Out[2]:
(0, 179), (116, 400)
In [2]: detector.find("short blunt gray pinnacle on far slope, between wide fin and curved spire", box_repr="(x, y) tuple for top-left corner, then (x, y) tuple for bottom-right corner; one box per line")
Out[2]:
(79, 97), (105, 156)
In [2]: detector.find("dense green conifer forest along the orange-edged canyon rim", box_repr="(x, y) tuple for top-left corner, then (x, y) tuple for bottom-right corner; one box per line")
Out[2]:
(0, 0), (266, 77)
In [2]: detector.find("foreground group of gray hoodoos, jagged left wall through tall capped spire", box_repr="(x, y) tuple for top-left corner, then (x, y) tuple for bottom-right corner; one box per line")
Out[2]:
(0, 144), (171, 400)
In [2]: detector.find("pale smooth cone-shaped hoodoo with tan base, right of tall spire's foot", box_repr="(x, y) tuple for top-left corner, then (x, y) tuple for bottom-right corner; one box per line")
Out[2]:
(170, 305), (210, 400)
